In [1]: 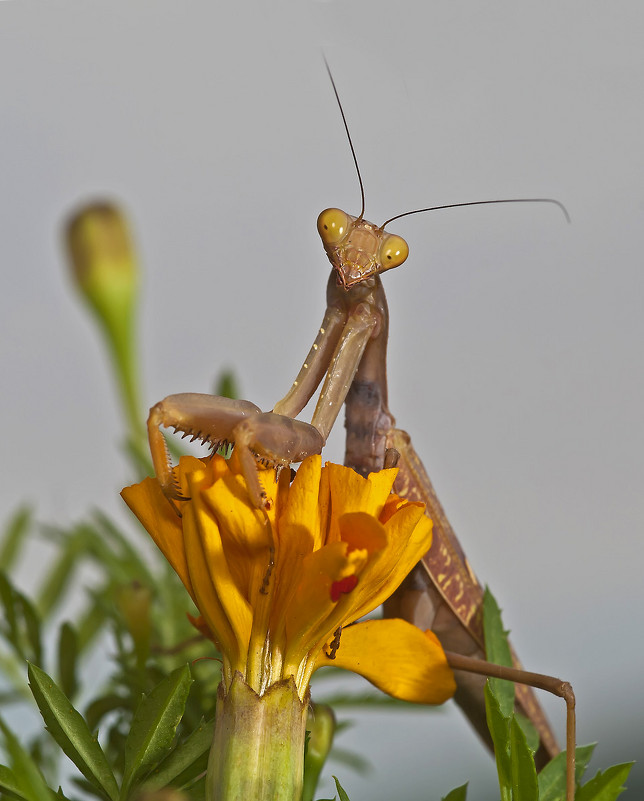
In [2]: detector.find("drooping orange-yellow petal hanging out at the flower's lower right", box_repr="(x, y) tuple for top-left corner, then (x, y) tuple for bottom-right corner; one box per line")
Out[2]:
(316, 620), (456, 704)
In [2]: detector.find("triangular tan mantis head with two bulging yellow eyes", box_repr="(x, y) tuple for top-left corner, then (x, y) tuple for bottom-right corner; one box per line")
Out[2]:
(318, 209), (409, 289)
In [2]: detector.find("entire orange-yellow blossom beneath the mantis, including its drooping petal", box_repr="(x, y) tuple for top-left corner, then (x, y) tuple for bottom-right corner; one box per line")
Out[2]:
(122, 455), (455, 704)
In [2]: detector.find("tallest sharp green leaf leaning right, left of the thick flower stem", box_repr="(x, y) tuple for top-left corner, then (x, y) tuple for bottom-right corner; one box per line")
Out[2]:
(121, 665), (192, 799)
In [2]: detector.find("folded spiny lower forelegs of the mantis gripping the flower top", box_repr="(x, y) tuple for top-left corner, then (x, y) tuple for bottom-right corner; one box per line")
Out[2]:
(148, 392), (324, 509)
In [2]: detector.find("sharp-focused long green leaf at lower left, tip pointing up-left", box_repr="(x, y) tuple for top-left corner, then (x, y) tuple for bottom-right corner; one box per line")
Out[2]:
(28, 664), (118, 801)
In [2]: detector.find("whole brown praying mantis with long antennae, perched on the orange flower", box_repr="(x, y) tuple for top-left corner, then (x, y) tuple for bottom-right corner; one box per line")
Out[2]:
(148, 64), (574, 801)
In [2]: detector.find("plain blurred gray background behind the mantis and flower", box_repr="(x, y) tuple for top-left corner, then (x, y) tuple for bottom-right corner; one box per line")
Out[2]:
(0, 0), (644, 801)
